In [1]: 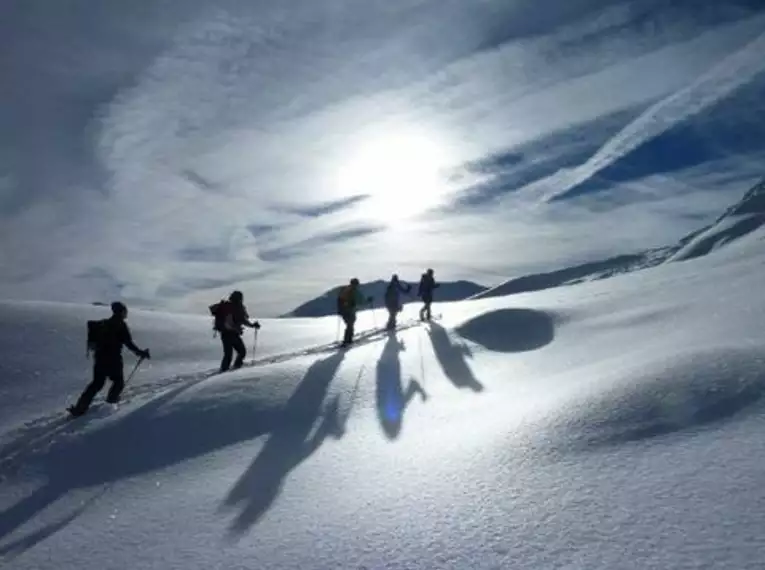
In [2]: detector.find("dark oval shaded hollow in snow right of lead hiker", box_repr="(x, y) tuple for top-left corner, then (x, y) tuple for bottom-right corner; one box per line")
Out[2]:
(456, 309), (555, 352)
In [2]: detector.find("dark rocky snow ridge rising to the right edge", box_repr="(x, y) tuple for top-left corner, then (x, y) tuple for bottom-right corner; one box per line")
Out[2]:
(472, 175), (765, 299)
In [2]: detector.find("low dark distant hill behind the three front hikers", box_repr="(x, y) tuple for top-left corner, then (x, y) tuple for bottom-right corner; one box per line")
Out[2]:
(284, 277), (486, 317)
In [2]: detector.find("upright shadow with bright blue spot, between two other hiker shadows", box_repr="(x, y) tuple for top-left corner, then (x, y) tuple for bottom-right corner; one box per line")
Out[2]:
(375, 334), (427, 439)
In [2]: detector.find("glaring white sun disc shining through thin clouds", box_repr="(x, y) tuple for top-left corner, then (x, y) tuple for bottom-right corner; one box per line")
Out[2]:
(336, 128), (450, 223)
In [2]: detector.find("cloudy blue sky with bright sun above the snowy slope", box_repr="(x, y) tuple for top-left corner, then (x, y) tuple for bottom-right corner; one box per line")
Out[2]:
(0, 0), (765, 316)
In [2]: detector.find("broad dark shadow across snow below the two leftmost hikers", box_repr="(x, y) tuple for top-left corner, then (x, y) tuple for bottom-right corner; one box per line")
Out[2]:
(0, 372), (279, 544)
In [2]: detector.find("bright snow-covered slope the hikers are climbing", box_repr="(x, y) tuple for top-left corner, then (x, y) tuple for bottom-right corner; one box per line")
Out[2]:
(0, 240), (765, 570)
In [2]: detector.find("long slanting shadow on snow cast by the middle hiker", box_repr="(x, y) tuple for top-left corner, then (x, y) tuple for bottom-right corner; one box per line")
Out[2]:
(224, 352), (344, 535)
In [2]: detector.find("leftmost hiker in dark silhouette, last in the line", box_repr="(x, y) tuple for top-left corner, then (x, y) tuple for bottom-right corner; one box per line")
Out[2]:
(69, 301), (151, 417)
